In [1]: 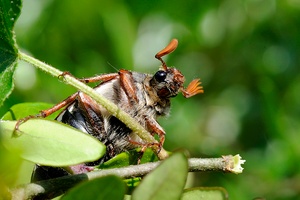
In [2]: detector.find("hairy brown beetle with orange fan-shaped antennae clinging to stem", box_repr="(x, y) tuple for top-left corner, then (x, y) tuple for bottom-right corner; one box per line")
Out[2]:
(19, 39), (203, 181)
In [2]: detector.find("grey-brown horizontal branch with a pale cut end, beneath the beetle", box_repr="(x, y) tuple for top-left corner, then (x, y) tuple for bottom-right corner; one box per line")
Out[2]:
(10, 155), (245, 200)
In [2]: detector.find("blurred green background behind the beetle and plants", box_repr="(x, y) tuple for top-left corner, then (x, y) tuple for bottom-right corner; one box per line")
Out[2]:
(0, 0), (300, 199)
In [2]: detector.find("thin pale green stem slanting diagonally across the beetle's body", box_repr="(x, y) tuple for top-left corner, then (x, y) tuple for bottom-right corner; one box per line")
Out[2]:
(19, 52), (168, 160)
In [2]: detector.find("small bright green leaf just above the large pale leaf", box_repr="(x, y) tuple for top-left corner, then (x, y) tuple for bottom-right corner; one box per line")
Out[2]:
(2, 102), (57, 120)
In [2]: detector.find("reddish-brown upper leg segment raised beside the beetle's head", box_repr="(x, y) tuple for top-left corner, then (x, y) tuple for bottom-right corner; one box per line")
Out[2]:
(119, 69), (138, 103)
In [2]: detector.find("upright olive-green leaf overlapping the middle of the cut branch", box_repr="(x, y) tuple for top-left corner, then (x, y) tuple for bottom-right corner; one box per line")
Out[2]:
(132, 153), (188, 200)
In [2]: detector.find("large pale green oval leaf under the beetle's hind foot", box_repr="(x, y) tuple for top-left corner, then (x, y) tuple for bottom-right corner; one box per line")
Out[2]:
(0, 119), (105, 166)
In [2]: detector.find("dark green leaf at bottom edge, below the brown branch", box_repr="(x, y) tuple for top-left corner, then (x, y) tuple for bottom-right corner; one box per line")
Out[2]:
(61, 176), (125, 200)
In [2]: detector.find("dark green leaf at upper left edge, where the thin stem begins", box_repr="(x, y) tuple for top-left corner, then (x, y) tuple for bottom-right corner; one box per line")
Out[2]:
(0, 0), (21, 106)
